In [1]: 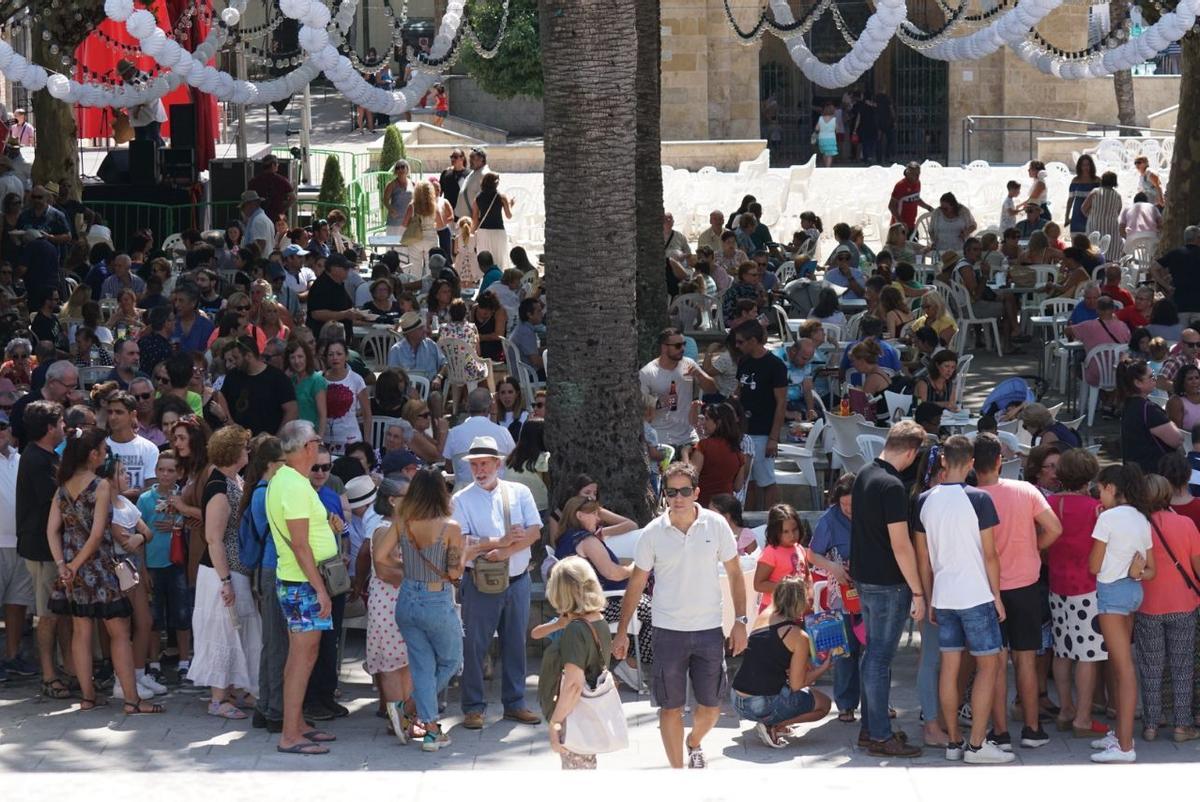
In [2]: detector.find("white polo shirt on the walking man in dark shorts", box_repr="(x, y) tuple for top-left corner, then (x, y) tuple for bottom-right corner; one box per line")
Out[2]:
(634, 504), (738, 632)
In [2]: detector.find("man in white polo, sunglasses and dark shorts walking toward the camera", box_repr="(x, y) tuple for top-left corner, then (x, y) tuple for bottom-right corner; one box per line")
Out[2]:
(612, 462), (746, 768)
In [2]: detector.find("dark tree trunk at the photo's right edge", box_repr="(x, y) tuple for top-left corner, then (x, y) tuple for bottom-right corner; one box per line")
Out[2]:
(1158, 36), (1200, 253)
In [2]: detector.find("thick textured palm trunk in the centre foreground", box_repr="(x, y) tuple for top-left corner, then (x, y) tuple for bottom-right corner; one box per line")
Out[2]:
(540, 0), (661, 521)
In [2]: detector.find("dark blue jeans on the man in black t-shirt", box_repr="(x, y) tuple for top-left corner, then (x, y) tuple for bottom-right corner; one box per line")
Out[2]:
(858, 582), (912, 741)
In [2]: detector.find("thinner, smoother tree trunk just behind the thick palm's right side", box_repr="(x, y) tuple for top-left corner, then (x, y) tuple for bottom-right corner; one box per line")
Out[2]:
(634, 0), (667, 363)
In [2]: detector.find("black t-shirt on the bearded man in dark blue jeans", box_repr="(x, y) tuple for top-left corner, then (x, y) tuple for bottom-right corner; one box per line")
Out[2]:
(850, 460), (908, 585)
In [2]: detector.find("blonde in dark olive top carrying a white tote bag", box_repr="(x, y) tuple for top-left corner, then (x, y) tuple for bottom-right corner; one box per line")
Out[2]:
(538, 557), (612, 770)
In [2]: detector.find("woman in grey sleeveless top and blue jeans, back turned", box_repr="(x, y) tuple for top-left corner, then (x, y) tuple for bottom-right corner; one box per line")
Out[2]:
(371, 468), (463, 752)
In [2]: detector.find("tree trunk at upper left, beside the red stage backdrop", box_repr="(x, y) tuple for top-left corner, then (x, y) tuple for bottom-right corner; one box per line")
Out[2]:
(30, 0), (104, 201)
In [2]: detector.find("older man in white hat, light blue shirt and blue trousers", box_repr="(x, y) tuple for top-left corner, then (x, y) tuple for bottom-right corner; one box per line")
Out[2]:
(452, 434), (541, 730)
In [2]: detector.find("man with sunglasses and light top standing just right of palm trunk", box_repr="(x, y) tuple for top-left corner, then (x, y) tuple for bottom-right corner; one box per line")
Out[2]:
(638, 329), (718, 461)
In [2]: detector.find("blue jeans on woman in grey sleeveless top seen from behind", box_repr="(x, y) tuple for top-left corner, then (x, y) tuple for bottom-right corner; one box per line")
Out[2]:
(396, 580), (462, 722)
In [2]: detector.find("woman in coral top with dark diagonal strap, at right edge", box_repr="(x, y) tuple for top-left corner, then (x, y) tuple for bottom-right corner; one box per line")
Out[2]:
(1133, 480), (1200, 742)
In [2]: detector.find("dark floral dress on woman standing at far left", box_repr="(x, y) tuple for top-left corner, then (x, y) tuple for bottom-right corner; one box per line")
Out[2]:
(50, 477), (133, 618)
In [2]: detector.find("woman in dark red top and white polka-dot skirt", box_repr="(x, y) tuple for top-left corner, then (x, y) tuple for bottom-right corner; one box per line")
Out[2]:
(1046, 448), (1109, 737)
